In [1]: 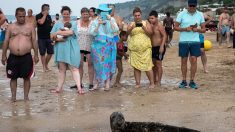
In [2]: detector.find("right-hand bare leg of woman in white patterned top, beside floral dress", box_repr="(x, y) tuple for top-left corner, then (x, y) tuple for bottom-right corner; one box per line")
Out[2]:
(86, 54), (94, 88)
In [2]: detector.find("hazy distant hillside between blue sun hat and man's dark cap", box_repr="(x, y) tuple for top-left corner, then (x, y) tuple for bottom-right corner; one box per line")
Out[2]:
(116, 0), (187, 21)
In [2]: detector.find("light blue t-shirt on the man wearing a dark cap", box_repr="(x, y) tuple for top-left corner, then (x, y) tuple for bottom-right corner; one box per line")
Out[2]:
(176, 10), (205, 42)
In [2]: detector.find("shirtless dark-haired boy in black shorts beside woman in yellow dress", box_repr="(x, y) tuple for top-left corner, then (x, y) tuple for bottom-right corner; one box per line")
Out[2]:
(149, 11), (166, 86)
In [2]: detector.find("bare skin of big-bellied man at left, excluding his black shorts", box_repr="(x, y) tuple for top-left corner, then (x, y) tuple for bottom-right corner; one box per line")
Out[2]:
(2, 8), (39, 102)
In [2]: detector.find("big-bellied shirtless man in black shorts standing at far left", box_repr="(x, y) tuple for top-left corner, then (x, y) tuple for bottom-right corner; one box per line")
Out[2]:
(2, 7), (39, 102)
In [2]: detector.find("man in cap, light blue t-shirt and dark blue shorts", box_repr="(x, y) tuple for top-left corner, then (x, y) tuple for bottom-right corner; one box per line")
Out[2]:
(174, 0), (206, 89)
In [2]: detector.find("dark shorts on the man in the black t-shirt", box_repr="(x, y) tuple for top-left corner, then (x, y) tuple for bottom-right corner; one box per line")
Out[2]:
(38, 39), (54, 55)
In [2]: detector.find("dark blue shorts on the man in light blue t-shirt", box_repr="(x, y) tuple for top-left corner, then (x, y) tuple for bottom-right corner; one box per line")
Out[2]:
(179, 42), (201, 57)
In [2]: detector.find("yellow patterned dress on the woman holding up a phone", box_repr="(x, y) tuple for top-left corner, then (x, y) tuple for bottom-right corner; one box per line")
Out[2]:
(128, 21), (153, 71)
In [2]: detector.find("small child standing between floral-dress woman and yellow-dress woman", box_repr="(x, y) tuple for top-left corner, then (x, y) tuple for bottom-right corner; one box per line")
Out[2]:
(114, 31), (129, 87)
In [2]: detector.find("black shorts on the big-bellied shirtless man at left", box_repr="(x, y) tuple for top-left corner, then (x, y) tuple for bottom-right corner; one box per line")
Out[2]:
(6, 53), (33, 79)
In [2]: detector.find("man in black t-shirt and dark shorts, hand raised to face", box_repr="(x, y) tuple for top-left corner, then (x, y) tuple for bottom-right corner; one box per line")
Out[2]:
(36, 4), (54, 72)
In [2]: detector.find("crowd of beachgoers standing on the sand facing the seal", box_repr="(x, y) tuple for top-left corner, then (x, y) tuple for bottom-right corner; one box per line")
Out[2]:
(0, 0), (235, 101)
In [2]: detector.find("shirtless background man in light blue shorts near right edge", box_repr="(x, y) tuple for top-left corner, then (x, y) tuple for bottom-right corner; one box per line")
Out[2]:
(219, 7), (231, 48)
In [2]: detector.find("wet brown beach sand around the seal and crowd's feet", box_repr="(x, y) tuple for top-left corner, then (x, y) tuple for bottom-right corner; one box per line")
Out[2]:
(0, 33), (235, 132)
